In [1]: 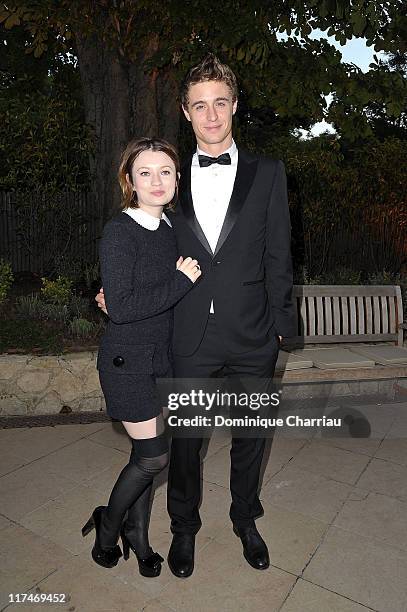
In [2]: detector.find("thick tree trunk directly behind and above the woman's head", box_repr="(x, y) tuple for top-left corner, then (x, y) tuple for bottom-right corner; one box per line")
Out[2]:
(76, 28), (179, 222)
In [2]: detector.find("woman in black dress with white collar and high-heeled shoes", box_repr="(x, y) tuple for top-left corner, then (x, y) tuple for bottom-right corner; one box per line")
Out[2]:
(82, 138), (201, 576)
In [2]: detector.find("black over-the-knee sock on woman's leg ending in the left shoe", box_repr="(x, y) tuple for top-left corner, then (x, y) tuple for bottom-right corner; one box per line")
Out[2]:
(100, 434), (168, 556)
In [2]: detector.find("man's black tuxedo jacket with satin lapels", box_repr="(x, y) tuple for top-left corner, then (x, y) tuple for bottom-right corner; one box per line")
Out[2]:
(170, 148), (295, 356)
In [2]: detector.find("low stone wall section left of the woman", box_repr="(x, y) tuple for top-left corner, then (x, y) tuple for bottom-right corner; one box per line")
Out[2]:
(0, 352), (105, 416)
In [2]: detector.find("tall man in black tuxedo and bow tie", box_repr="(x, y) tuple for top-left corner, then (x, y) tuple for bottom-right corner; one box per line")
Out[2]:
(97, 54), (295, 578)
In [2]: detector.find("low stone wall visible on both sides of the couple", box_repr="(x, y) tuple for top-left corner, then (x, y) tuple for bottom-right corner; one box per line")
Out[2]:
(0, 351), (407, 416)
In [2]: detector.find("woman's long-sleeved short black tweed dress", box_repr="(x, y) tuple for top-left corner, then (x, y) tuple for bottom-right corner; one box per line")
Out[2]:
(97, 212), (193, 422)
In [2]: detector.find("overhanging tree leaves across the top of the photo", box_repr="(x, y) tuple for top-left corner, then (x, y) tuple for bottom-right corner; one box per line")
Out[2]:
(0, 0), (407, 139)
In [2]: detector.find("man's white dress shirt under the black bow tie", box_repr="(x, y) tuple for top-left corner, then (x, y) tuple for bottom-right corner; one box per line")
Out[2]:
(191, 140), (239, 313)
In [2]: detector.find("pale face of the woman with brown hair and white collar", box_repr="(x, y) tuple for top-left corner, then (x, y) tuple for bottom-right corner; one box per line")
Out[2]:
(127, 151), (177, 215)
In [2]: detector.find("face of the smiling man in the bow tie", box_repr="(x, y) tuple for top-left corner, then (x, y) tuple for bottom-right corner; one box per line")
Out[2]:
(183, 81), (237, 150)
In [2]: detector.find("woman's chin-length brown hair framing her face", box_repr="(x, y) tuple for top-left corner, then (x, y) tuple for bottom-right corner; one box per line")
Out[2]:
(118, 137), (180, 210)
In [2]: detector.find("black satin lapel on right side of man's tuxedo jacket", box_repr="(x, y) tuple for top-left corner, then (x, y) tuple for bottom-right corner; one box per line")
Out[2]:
(214, 149), (258, 256)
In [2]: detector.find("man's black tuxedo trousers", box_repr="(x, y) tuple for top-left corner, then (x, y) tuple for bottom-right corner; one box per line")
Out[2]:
(167, 315), (279, 534)
